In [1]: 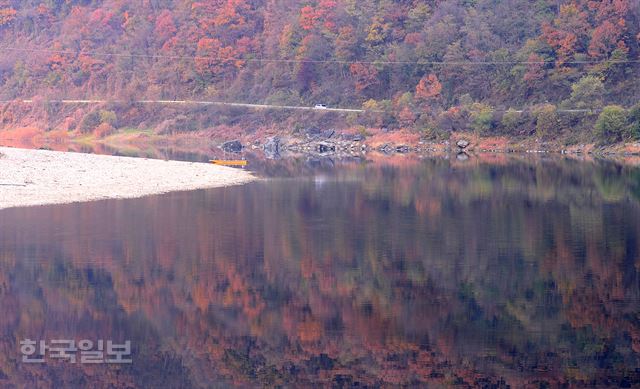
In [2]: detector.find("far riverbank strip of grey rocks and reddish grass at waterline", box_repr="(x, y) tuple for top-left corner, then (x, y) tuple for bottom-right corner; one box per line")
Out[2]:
(0, 126), (640, 158)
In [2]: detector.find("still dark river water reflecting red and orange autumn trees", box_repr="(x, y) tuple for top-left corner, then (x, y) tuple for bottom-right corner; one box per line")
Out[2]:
(0, 159), (640, 387)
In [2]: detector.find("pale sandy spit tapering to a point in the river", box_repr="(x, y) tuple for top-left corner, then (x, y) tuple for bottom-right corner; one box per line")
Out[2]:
(0, 147), (255, 209)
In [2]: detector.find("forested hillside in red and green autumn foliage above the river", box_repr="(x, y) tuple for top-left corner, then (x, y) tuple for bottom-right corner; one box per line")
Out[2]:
(0, 0), (640, 141)
